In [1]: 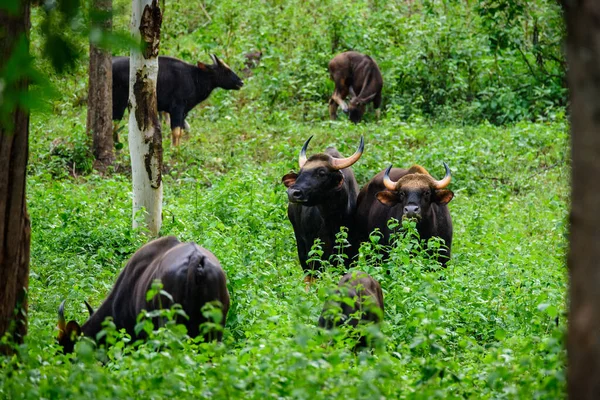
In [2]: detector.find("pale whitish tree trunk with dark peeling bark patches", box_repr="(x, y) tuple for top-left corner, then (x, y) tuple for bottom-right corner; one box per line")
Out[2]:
(129, 0), (162, 236)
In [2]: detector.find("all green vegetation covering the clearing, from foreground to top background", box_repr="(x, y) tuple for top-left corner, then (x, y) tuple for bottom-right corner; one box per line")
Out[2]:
(0, 1), (569, 399)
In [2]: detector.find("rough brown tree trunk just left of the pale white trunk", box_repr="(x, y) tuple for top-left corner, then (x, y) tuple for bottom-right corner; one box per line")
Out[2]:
(87, 0), (115, 171)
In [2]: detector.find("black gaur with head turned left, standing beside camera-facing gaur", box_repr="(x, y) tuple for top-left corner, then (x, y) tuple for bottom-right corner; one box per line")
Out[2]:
(281, 136), (364, 281)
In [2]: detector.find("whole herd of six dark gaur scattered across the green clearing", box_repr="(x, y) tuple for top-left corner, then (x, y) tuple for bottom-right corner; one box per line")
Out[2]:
(58, 51), (454, 353)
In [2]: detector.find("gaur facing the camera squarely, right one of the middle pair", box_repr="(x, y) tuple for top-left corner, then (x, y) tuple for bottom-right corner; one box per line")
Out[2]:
(356, 163), (454, 266)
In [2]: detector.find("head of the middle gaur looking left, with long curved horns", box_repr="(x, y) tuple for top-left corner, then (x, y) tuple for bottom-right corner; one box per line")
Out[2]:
(281, 136), (365, 206)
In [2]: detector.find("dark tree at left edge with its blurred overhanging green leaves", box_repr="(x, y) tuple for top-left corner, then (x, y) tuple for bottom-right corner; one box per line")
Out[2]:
(0, 0), (122, 353)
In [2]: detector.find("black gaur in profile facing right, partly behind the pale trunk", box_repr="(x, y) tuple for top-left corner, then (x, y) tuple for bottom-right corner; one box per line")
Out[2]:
(112, 54), (244, 146)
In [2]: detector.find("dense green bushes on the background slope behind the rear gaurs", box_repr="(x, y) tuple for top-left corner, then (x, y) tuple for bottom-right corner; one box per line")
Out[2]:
(158, 0), (566, 124)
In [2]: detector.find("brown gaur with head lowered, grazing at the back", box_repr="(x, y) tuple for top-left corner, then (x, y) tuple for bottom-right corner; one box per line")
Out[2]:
(329, 51), (383, 123)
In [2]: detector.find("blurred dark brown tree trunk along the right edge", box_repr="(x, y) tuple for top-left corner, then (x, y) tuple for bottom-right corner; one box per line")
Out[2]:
(564, 0), (600, 400)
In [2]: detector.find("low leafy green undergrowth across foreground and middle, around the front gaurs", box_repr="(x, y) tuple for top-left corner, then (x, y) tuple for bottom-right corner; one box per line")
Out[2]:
(0, 104), (569, 399)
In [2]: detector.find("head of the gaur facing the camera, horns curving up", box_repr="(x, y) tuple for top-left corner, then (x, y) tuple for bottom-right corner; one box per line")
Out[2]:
(377, 163), (454, 219)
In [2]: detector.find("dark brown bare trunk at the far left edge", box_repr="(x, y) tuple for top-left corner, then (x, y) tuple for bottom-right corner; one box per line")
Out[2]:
(0, 1), (30, 354)
